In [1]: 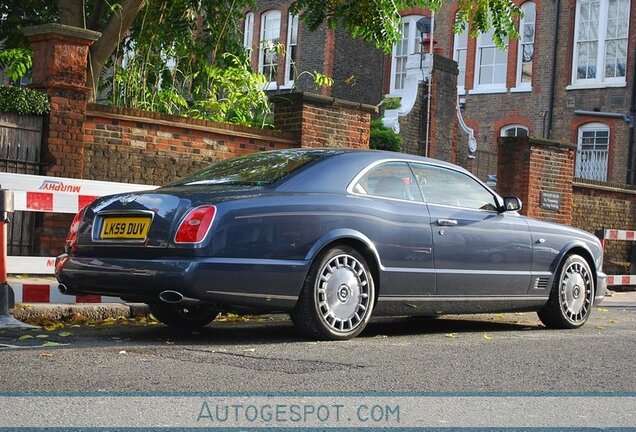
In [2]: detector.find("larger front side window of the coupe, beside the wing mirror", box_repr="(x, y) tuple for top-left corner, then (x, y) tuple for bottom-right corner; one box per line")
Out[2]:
(412, 164), (497, 211)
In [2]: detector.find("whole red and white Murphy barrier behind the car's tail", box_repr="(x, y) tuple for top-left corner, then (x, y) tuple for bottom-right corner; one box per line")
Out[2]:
(0, 173), (157, 303)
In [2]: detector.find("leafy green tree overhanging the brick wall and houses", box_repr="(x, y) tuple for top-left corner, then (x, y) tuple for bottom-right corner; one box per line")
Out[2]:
(0, 0), (521, 124)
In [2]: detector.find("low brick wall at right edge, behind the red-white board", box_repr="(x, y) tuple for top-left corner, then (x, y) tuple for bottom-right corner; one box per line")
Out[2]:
(572, 180), (636, 274)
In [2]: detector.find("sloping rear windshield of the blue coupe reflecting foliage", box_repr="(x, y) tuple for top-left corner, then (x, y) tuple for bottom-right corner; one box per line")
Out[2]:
(170, 150), (334, 186)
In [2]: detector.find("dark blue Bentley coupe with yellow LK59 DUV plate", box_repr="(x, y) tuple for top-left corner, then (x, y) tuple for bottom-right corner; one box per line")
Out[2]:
(56, 149), (606, 339)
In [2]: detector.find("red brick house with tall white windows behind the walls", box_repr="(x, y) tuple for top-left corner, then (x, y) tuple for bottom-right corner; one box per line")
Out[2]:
(243, 0), (636, 184)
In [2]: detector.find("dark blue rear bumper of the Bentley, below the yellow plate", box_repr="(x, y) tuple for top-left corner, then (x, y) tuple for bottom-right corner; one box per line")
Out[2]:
(55, 255), (309, 311)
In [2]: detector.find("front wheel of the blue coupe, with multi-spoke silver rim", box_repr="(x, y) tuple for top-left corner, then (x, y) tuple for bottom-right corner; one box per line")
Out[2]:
(537, 254), (595, 329)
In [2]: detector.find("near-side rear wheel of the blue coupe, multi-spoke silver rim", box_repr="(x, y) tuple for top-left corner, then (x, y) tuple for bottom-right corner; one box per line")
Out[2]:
(291, 246), (375, 340)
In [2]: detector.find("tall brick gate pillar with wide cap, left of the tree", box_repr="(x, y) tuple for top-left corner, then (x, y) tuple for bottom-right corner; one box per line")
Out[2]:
(23, 24), (100, 178)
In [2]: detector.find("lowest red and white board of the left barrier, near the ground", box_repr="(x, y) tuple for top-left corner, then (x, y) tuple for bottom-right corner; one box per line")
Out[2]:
(9, 281), (122, 304)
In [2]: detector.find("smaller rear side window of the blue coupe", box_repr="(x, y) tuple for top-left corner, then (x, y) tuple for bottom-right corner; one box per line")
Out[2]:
(353, 162), (422, 201)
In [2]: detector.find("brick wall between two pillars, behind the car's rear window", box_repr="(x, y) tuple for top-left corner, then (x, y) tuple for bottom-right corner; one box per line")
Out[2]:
(82, 105), (297, 185)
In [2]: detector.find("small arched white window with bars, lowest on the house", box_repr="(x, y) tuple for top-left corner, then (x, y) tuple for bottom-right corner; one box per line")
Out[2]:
(574, 122), (610, 181)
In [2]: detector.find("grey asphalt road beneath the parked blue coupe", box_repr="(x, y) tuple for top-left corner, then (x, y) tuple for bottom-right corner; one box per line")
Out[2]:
(0, 307), (636, 392)
